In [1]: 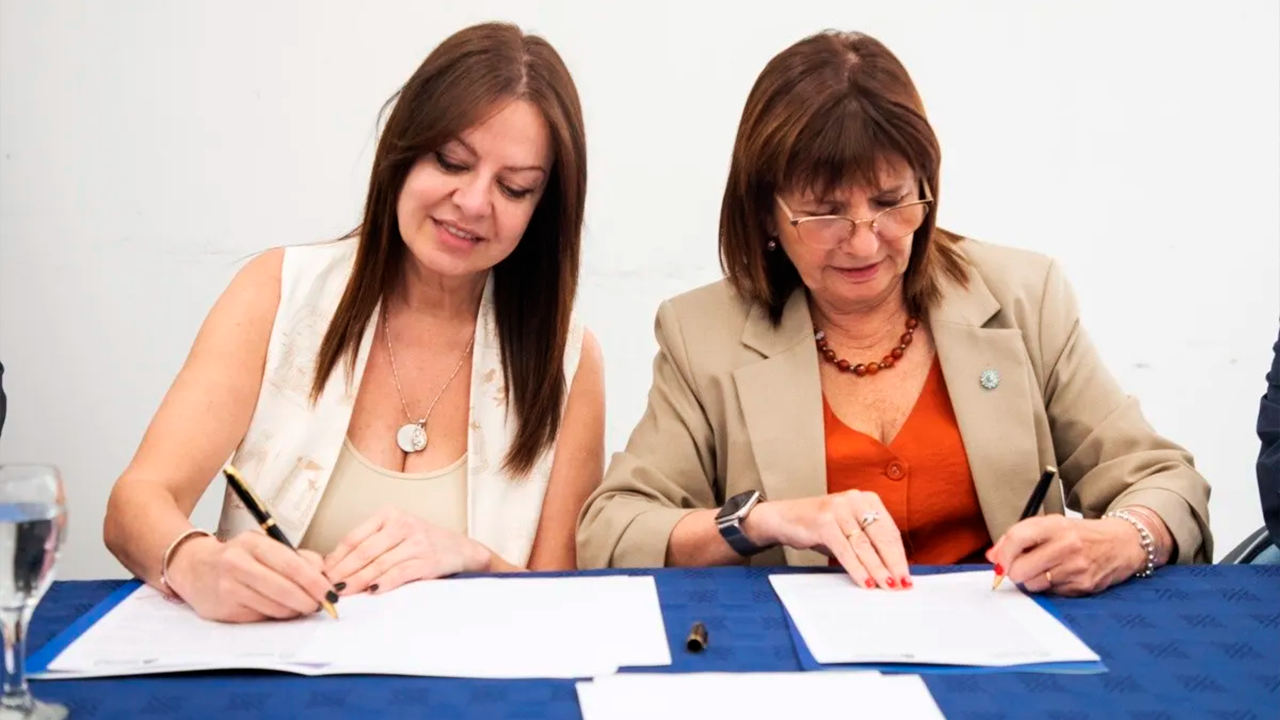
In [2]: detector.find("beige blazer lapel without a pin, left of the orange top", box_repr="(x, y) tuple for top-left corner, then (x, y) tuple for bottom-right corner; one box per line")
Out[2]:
(733, 291), (827, 565)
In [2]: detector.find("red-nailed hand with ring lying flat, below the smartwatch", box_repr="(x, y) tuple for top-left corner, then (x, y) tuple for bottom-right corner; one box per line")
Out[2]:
(742, 489), (911, 589)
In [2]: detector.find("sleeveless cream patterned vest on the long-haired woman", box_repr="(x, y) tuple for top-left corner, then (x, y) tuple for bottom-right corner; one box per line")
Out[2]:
(218, 238), (582, 566)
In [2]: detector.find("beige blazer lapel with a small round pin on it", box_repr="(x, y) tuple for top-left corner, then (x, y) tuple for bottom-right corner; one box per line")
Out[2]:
(929, 273), (1060, 541)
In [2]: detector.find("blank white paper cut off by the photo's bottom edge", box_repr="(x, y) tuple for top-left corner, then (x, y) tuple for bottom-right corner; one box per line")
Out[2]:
(576, 671), (943, 720)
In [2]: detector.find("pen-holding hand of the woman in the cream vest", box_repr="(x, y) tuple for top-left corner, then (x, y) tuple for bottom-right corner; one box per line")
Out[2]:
(169, 530), (338, 623)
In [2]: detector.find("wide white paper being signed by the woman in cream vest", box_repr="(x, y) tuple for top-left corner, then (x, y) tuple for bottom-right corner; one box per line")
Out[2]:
(35, 577), (671, 679)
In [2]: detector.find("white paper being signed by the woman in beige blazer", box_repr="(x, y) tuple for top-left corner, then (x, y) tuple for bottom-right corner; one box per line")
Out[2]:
(769, 571), (1098, 666)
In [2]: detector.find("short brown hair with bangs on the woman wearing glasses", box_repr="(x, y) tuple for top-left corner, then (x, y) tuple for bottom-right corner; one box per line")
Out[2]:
(719, 31), (968, 323)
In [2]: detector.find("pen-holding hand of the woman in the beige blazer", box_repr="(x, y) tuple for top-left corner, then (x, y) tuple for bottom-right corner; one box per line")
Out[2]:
(987, 515), (1147, 596)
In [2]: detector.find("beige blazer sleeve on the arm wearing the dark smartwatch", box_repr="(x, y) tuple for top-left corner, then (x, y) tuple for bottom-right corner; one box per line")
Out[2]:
(577, 301), (716, 569)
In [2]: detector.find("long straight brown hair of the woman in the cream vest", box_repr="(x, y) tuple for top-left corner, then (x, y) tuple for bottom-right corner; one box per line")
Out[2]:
(311, 23), (586, 475)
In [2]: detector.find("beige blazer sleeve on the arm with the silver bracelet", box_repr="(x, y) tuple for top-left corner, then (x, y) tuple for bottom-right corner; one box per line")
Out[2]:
(1039, 263), (1213, 564)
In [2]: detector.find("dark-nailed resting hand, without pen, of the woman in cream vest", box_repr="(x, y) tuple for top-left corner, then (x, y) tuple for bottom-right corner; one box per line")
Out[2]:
(324, 507), (493, 594)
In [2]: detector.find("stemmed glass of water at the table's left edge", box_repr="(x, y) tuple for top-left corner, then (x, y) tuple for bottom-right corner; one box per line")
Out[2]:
(0, 465), (67, 720)
